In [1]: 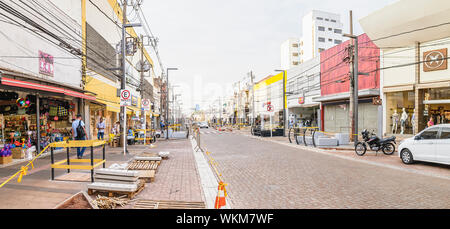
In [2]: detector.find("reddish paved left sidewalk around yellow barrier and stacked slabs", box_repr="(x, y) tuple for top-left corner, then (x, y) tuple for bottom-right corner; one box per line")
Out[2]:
(0, 139), (203, 209)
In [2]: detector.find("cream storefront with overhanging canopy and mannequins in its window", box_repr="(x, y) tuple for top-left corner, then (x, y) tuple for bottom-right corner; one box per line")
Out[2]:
(360, 0), (450, 137)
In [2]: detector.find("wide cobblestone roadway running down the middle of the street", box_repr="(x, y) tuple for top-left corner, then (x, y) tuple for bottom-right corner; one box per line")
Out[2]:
(201, 130), (450, 209)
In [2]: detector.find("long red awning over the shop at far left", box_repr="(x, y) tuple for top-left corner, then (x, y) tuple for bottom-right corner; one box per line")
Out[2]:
(1, 77), (95, 100)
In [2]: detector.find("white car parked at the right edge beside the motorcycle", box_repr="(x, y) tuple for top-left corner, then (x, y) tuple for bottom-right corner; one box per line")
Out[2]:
(398, 124), (450, 165)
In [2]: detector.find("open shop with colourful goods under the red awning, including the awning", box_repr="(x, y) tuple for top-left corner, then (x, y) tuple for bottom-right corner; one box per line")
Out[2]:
(0, 72), (95, 161)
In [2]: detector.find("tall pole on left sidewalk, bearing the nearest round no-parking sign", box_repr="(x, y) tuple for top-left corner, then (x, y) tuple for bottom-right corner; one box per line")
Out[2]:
(120, 0), (128, 155)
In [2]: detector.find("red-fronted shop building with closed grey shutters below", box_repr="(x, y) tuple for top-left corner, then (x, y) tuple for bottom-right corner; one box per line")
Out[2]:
(313, 34), (383, 135)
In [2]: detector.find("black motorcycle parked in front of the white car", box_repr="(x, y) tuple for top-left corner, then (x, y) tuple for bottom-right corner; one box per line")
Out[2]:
(355, 130), (397, 156)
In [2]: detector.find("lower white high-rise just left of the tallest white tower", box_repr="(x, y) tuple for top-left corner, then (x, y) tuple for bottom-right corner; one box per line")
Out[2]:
(281, 38), (300, 69)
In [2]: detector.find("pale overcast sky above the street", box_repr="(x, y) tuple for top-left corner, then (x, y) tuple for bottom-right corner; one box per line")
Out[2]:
(138, 0), (396, 112)
